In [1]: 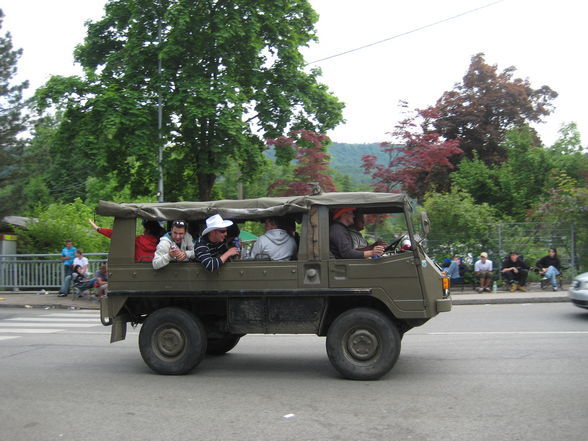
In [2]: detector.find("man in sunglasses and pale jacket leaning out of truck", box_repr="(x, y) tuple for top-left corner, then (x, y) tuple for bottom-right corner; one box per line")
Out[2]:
(152, 220), (194, 269)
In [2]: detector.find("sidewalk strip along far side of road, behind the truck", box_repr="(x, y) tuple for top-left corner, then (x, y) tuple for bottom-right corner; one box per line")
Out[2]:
(0, 286), (569, 309)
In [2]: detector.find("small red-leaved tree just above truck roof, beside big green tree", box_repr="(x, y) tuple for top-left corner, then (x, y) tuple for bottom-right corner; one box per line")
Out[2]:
(266, 130), (336, 196)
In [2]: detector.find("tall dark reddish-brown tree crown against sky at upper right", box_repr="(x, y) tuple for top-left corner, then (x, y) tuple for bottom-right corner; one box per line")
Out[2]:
(435, 53), (557, 164)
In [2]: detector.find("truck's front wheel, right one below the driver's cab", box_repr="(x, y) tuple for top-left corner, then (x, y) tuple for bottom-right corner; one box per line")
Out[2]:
(327, 308), (400, 380)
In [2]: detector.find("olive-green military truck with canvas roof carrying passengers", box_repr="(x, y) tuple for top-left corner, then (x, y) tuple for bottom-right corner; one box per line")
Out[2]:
(97, 192), (451, 380)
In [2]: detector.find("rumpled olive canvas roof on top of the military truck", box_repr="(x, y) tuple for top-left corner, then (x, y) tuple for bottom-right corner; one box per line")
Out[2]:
(96, 192), (409, 220)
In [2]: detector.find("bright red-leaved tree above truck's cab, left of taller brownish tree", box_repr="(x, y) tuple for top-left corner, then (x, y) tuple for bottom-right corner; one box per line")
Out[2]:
(362, 103), (463, 200)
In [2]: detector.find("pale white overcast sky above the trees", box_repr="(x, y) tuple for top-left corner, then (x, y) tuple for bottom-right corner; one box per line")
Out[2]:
(1, 0), (588, 145)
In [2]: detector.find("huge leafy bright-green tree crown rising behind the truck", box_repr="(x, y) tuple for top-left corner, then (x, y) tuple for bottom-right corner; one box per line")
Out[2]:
(36, 0), (343, 200)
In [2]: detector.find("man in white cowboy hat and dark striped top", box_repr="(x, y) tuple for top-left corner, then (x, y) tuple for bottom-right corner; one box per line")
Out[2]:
(194, 214), (239, 272)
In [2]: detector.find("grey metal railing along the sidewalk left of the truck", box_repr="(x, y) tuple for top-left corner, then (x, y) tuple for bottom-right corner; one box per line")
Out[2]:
(0, 253), (108, 291)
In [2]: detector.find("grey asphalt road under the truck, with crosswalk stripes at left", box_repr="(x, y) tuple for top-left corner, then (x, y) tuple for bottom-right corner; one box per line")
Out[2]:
(0, 303), (588, 441)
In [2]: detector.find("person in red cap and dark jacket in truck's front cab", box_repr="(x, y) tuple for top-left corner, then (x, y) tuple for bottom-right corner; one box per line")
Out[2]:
(329, 207), (384, 259)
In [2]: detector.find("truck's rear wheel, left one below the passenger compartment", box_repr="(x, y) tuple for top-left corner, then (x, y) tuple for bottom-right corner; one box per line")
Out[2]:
(139, 307), (207, 375)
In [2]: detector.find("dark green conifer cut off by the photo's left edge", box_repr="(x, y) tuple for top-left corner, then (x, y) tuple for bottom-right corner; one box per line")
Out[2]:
(0, 9), (28, 219)
